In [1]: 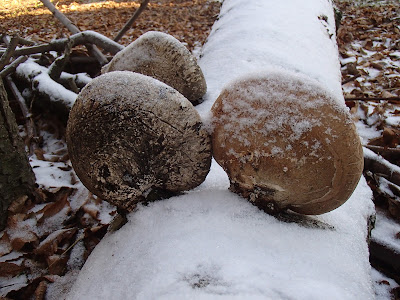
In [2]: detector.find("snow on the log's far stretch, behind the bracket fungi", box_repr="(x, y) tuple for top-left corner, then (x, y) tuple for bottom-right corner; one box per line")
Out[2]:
(195, 0), (343, 119)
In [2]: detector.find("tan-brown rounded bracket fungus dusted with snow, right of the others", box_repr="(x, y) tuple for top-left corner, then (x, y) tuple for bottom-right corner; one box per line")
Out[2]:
(212, 71), (363, 215)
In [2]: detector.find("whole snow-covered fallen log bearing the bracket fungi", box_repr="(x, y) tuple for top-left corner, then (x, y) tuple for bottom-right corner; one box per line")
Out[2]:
(69, 0), (374, 300)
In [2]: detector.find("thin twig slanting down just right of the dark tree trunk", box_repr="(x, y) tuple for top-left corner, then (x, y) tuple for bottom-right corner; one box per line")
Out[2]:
(6, 76), (37, 155)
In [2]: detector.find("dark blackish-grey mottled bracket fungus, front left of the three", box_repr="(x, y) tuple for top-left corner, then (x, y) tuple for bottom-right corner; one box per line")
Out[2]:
(66, 71), (211, 211)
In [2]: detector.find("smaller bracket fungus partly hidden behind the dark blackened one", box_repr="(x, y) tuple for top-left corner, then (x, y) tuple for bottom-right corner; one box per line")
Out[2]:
(102, 31), (207, 103)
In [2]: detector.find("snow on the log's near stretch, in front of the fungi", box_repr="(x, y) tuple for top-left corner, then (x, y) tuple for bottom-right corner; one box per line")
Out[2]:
(68, 164), (373, 299)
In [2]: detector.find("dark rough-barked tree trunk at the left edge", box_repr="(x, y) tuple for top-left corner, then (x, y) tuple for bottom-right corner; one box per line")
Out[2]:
(0, 80), (35, 230)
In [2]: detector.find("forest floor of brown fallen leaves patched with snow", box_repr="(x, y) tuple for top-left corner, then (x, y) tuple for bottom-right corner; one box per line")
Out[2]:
(0, 0), (400, 299)
